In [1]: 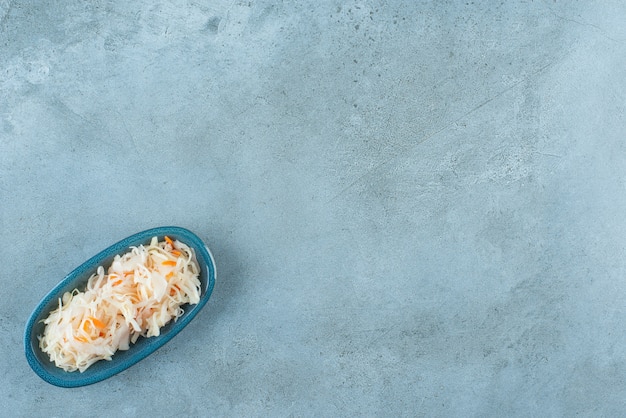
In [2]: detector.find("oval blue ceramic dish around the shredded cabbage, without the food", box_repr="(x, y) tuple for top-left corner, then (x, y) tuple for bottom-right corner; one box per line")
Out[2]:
(24, 226), (215, 388)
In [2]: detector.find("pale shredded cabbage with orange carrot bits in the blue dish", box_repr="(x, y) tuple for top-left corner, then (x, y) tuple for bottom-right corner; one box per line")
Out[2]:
(39, 237), (200, 372)
